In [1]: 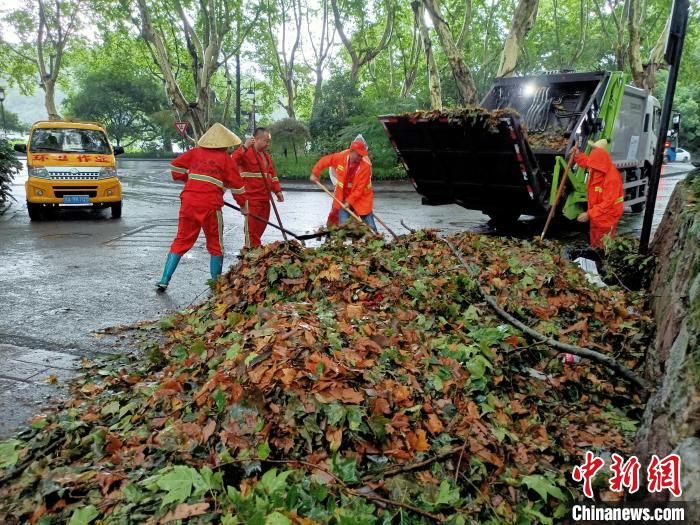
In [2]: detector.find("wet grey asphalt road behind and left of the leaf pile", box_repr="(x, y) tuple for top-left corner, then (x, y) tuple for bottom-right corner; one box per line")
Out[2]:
(0, 160), (692, 437)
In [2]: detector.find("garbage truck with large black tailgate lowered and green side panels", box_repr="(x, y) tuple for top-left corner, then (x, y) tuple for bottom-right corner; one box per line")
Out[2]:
(379, 72), (661, 225)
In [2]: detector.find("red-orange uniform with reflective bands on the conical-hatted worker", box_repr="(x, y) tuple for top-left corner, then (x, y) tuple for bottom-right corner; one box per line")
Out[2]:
(170, 147), (245, 256)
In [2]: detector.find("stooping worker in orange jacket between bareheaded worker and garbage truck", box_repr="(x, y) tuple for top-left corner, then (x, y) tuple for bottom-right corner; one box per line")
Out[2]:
(311, 135), (377, 231)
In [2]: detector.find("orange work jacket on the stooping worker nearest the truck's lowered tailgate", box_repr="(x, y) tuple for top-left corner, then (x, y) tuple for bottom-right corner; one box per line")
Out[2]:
(311, 149), (374, 216)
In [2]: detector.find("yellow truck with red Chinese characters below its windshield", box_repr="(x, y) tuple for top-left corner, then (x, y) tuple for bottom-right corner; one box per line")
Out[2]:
(14, 120), (124, 221)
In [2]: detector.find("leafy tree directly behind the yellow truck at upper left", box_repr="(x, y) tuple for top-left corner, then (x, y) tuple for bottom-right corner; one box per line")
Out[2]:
(0, 0), (84, 120)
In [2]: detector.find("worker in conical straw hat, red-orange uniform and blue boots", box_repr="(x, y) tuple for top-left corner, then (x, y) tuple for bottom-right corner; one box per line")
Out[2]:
(156, 123), (245, 291)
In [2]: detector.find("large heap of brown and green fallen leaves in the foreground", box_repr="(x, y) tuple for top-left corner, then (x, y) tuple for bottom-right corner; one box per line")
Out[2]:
(0, 230), (649, 525)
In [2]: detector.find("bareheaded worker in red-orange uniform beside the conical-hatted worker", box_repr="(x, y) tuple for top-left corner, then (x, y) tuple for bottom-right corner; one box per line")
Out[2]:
(232, 128), (284, 248)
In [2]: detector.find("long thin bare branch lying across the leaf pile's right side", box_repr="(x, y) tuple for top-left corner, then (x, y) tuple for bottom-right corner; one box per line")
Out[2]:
(442, 239), (652, 393)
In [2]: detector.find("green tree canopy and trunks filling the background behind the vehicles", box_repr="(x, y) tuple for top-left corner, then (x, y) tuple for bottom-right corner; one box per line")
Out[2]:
(0, 0), (700, 154)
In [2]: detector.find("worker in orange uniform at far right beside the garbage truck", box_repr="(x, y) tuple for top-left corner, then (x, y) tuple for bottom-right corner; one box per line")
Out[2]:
(574, 139), (625, 248)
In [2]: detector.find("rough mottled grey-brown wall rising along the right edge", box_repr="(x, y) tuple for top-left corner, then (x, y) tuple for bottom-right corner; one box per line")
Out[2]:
(636, 171), (700, 512)
